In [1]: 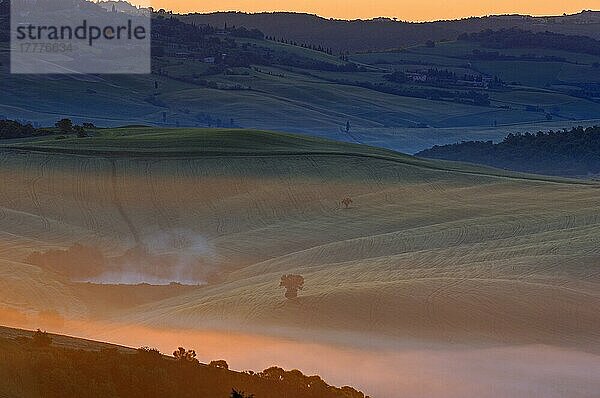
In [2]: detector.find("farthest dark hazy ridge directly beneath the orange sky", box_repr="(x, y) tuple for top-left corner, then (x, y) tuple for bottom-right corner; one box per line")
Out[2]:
(180, 11), (600, 52)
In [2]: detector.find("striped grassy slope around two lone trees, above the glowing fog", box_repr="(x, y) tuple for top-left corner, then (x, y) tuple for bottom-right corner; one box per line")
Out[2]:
(0, 130), (600, 350)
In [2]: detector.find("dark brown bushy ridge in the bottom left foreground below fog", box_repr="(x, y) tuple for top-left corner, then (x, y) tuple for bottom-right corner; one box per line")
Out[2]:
(0, 327), (365, 398)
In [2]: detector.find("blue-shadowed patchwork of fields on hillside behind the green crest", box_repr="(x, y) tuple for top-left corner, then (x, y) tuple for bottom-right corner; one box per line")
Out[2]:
(0, 39), (600, 153)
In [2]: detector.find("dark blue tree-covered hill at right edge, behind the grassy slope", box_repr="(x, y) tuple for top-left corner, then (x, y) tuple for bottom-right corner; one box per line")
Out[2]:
(417, 127), (600, 176)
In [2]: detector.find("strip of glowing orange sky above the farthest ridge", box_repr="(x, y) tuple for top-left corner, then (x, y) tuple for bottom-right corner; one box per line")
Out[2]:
(142, 0), (600, 21)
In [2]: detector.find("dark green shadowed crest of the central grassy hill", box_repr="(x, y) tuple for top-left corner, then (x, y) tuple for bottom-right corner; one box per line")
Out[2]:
(0, 127), (583, 183)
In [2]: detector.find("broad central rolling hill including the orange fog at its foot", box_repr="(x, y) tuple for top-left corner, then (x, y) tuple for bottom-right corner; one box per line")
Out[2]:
(0, 127), (600, 397)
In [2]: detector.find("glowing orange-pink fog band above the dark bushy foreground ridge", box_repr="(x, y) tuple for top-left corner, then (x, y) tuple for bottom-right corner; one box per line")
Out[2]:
(48, 327), (600, 398)
